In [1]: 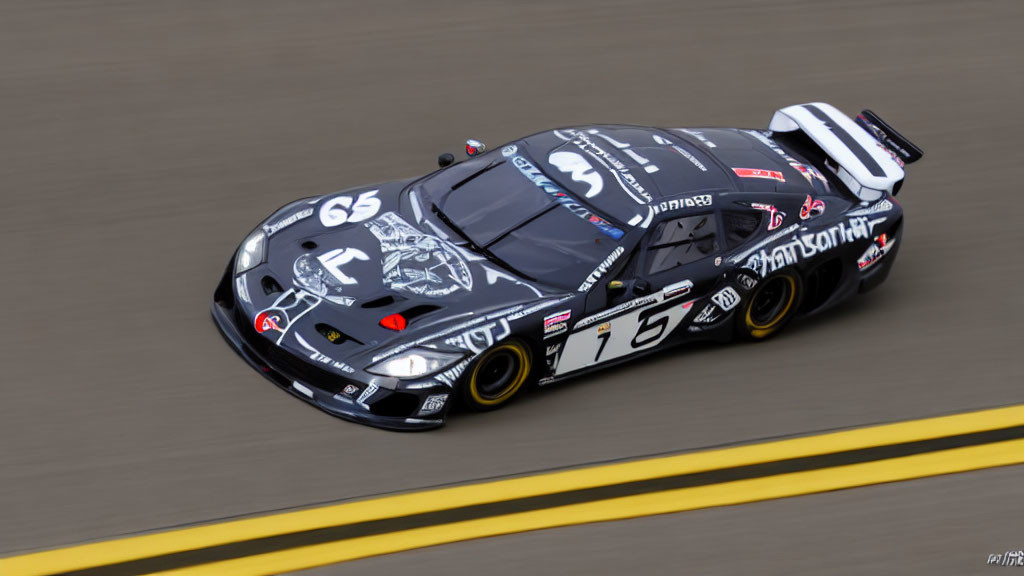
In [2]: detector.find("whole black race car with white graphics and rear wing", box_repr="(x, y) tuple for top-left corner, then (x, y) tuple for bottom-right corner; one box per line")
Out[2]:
(212, 102), (923, 429)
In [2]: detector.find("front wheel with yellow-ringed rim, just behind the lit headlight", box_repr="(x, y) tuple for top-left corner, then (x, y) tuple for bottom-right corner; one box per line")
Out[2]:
(459, 339), (534, 412)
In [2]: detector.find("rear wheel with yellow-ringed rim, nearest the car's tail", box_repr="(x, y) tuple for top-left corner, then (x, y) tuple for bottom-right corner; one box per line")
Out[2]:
(736, 270), (804, 340)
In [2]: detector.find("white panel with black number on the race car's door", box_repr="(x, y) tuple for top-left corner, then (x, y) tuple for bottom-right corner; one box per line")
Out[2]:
(555, 290), (693, 375)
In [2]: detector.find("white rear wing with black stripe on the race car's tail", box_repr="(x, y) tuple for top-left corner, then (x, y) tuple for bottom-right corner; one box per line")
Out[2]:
(768, 102), (924, 201)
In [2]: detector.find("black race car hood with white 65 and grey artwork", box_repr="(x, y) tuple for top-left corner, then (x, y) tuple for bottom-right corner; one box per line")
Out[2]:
(244, 182), (554, 368)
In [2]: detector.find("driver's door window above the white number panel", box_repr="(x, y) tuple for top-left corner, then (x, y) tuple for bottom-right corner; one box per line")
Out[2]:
(645, 212), (721, 276)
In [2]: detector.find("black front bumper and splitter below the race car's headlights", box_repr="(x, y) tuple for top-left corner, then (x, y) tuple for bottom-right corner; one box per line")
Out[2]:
(210, 265), (452, 430)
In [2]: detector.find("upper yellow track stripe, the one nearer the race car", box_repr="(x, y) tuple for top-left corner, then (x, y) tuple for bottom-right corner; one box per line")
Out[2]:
(0, 405), (1024, 576)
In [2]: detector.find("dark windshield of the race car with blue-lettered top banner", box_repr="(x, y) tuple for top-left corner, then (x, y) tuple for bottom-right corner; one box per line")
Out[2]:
(425, 155), (625, 289)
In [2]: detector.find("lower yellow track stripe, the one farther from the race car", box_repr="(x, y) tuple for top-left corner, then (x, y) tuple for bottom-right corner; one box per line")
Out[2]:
(151, 440), (1024, 576)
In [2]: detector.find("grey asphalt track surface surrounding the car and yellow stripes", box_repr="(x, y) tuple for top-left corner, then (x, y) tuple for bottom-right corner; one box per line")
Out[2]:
(0, 0), (1024, 574)
